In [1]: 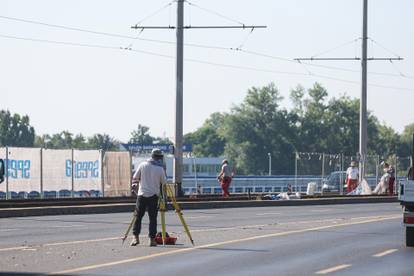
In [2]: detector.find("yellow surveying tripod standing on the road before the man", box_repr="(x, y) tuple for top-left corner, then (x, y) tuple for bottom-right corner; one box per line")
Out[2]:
(122, 183), (194, 245)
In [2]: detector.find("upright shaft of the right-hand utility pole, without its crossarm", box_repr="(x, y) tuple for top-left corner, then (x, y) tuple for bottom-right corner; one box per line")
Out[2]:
(359, 0), (368, 181)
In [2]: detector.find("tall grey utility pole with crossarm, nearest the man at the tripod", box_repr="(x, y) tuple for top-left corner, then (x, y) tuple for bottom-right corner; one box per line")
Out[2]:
(131, 0), (266, 196)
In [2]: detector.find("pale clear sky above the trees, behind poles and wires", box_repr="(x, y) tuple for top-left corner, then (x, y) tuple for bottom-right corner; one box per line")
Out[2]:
(0, 0), (414, 141)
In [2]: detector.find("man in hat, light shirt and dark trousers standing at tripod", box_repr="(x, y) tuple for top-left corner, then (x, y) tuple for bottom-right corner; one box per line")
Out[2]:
(131, 149), (166, 246)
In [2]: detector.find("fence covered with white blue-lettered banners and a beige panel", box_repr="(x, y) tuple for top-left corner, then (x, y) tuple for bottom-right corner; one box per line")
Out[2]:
(0, 147), (131, 199)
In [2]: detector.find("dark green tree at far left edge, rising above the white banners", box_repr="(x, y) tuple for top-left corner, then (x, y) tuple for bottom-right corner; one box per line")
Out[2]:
(0, 110), (35, 147)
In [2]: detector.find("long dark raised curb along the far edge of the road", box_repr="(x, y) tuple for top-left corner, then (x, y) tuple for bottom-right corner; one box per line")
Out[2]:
(0, 197), (398, 218)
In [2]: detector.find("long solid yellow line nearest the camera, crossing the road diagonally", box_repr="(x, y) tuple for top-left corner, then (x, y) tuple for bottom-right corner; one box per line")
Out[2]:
(48, 215), (401, 275)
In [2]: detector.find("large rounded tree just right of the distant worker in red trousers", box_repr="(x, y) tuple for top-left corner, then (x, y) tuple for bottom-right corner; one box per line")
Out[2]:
(222, 83), (295, 174)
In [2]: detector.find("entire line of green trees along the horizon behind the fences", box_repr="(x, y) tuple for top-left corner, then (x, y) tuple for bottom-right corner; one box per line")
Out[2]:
(0, 83), (414, 174)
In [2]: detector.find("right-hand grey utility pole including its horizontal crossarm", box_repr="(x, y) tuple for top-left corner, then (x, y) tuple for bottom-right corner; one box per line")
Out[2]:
(295, 0), (403, 181)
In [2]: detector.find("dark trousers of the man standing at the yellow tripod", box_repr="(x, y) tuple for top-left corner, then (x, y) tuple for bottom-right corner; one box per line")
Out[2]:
(132, 195), (158, 238)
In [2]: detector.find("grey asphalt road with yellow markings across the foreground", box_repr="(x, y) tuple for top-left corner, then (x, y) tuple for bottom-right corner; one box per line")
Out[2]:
(0, 203), (414, 276)
